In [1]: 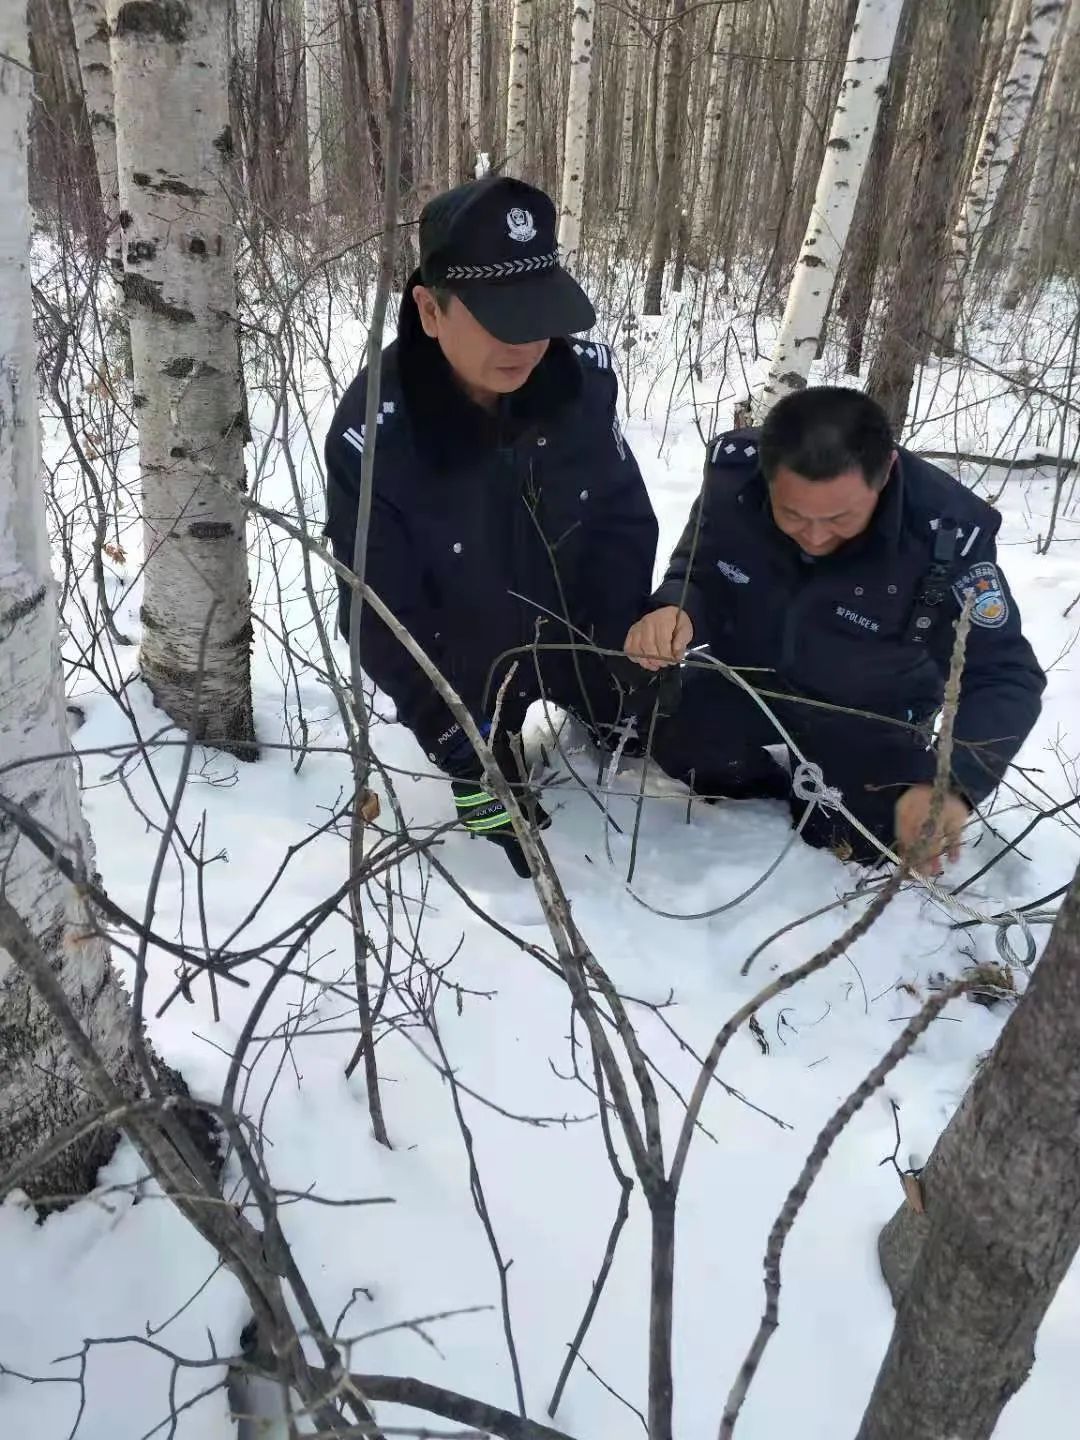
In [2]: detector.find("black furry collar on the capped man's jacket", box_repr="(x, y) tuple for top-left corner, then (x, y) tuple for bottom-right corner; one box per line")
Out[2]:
(397, 271), (583, 471)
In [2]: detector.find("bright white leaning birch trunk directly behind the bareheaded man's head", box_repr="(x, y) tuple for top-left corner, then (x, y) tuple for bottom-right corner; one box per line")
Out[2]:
(755, 0), (903, 420)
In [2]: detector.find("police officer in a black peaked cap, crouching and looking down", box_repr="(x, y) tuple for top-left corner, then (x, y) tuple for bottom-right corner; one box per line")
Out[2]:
(325, 176), (657, 874)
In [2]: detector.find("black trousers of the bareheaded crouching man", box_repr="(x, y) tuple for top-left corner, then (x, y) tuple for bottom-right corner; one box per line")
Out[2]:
(652, 671), (932, 863)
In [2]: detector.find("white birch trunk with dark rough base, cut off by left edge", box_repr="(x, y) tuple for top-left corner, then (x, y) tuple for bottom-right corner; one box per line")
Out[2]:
(0, 28), (135, 1197)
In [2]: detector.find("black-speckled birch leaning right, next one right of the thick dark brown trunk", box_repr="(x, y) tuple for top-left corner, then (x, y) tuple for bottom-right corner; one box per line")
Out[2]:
(939, 0), (1064, 353)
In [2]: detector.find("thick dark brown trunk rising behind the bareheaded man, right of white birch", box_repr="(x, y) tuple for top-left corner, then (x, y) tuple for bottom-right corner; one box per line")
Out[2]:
(867, 0), (989, 436)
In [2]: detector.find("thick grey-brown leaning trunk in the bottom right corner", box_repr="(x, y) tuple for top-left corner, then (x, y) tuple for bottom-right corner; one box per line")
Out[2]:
(857, 871), (1080, 1440)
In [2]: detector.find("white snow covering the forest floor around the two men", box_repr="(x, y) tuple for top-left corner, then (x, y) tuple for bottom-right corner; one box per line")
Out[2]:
(0, 272), (1080, 1440)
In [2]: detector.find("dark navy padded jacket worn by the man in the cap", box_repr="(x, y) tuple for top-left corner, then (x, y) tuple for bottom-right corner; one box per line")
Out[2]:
(325, 300), (657, 759)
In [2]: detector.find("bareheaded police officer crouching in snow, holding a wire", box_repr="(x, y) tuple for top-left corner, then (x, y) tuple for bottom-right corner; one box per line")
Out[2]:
(626, 387), (1045, 870)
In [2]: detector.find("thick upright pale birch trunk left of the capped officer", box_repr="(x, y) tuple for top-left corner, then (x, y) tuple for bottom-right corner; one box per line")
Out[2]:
(109, 0), (255, 759)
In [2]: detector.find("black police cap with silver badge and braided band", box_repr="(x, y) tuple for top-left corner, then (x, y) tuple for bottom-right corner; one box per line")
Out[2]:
(420, 176), (596, 346)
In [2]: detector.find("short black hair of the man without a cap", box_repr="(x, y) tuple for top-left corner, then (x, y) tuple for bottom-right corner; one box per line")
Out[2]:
(757, 384), (896, 490)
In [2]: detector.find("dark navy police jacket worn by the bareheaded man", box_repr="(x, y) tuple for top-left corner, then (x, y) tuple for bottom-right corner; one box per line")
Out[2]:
(652, 431), (1045, 804)
